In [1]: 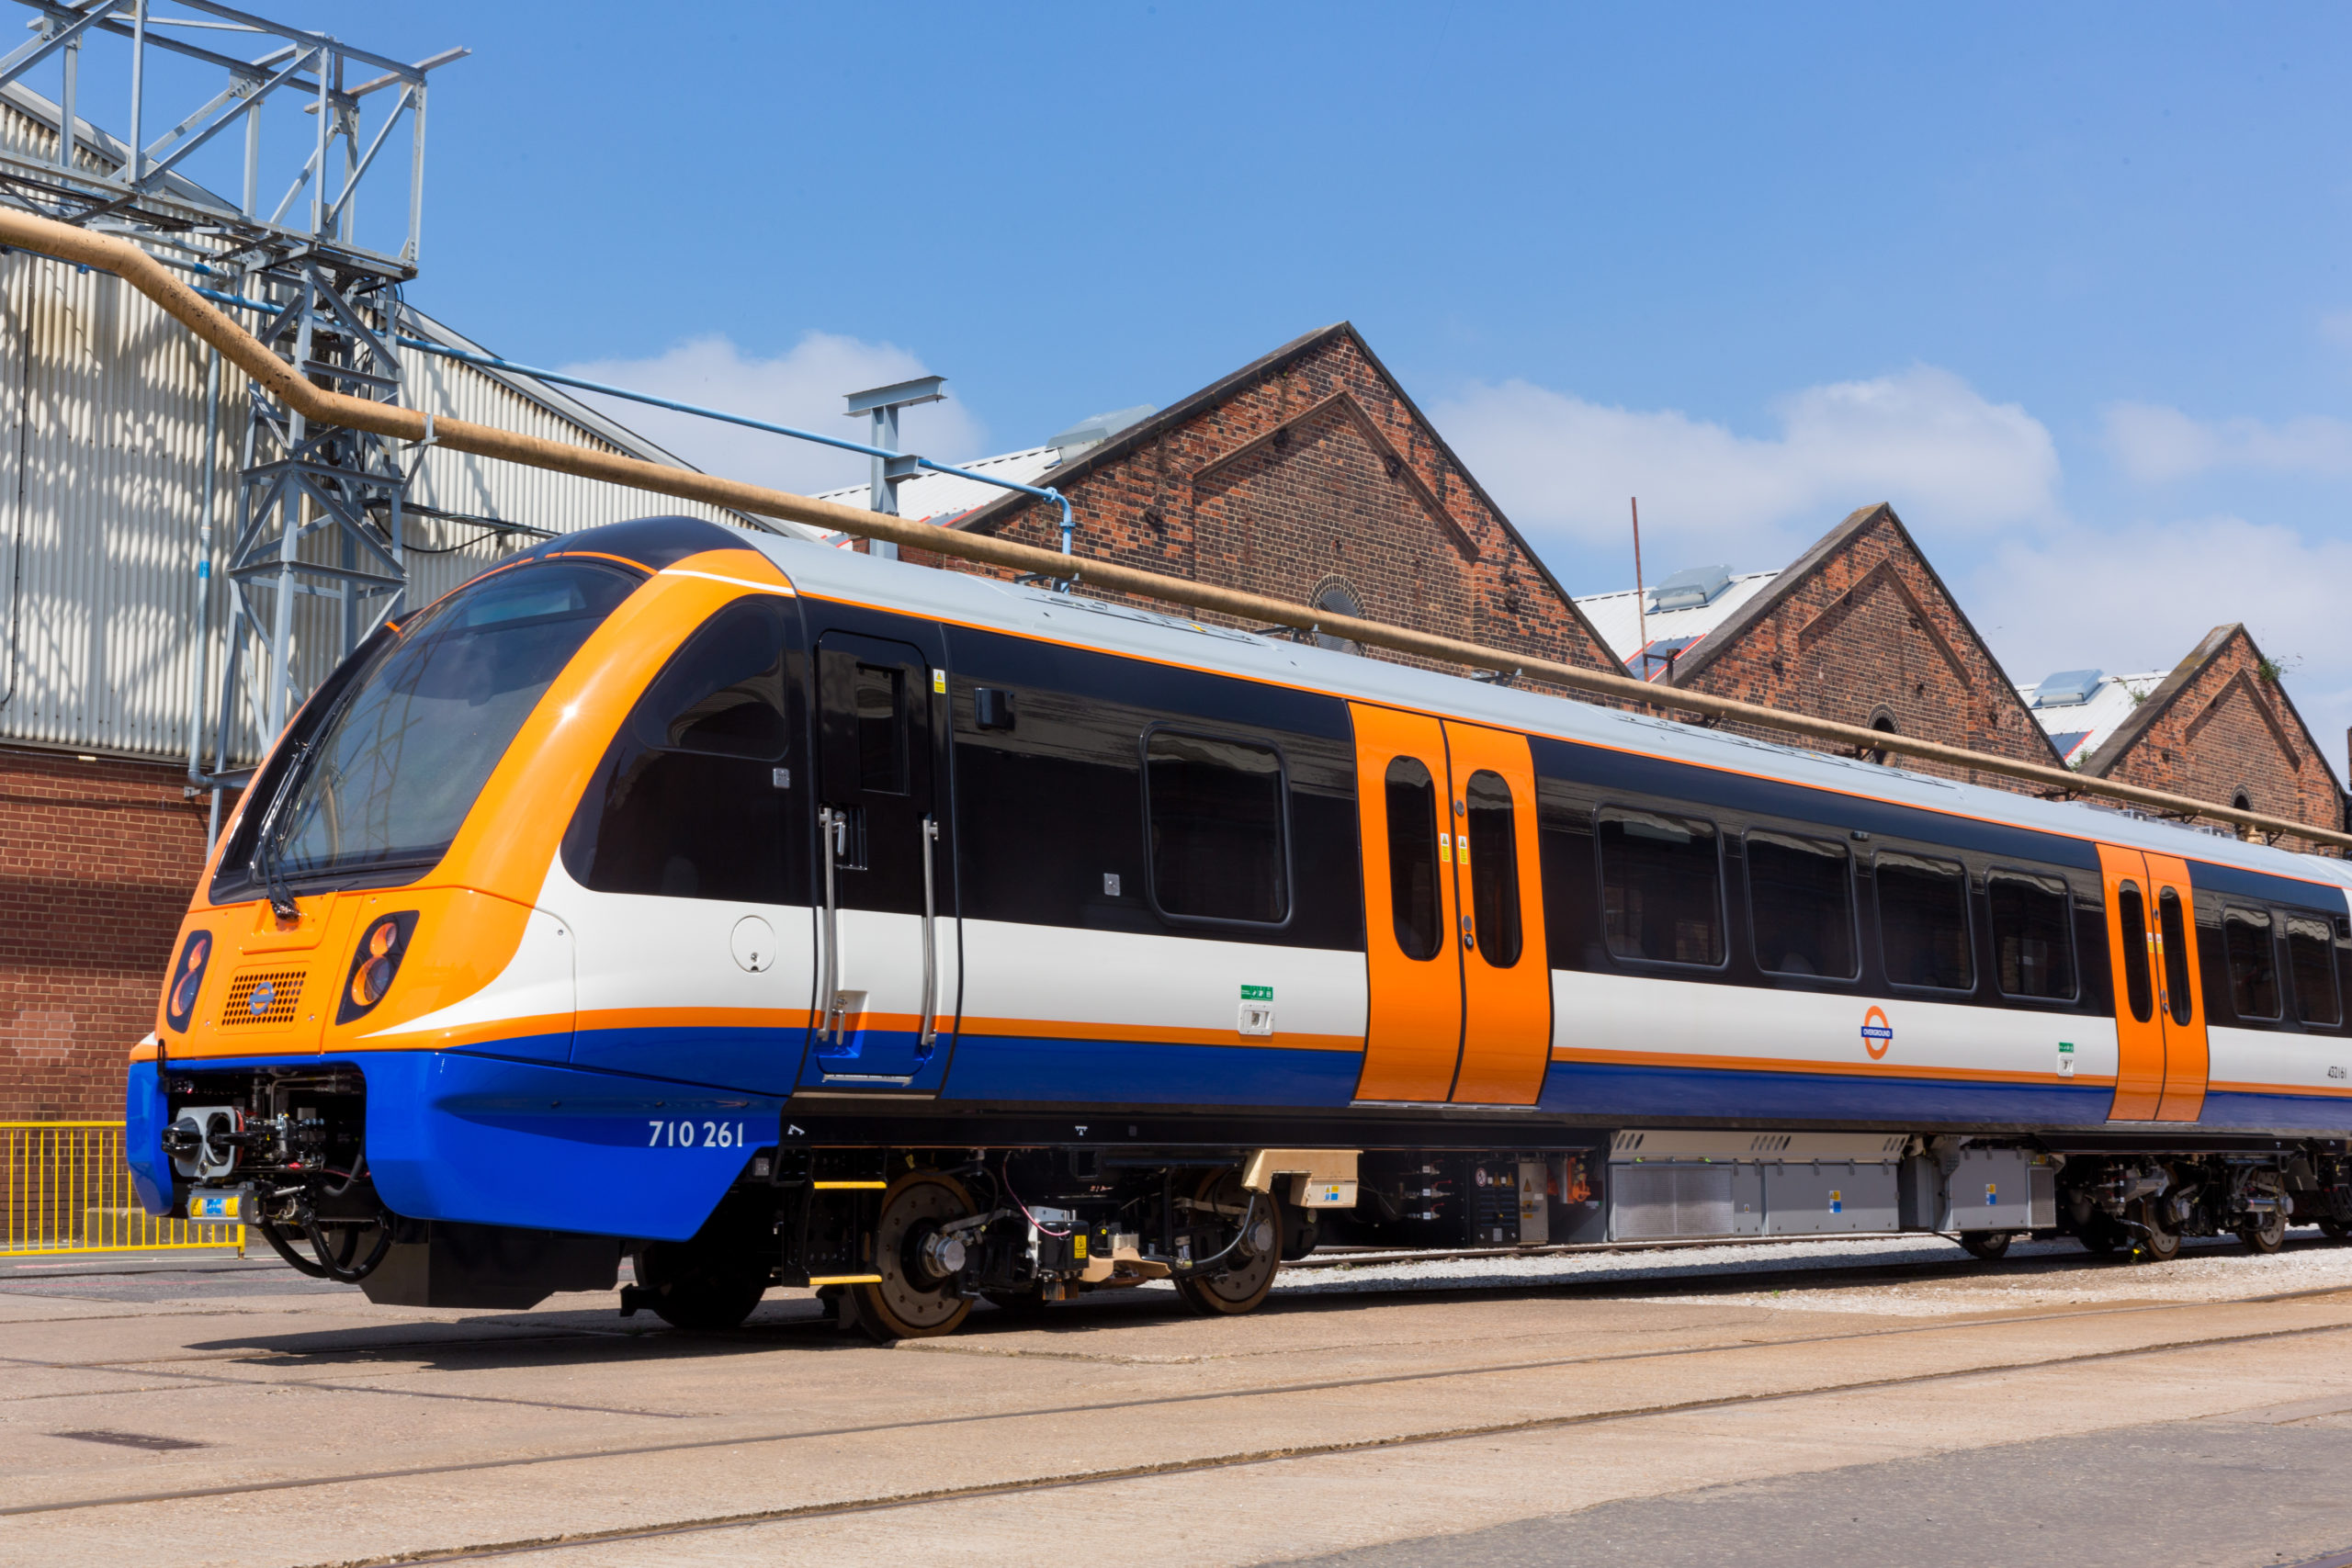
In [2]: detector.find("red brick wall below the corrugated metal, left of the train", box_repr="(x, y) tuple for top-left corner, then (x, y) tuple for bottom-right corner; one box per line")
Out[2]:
(0, 750), (205, 1119)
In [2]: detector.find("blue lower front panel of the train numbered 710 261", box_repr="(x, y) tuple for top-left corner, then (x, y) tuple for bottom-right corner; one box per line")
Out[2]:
(356, 1051), (783, 1241)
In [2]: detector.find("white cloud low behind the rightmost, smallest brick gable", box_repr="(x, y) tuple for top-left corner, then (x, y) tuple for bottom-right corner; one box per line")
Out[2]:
(1964, 517), (2352, 776)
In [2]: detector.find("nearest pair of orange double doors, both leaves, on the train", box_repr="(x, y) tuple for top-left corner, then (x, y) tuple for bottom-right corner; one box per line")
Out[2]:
(1352, 705), (1553, 1105)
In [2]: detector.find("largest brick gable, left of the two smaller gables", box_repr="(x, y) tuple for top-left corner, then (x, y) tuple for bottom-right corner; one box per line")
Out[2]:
(908, 327), (1616, 691)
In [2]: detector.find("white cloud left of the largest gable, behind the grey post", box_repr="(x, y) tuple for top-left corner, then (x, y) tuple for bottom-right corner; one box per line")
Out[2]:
(562, 332), (983, 491)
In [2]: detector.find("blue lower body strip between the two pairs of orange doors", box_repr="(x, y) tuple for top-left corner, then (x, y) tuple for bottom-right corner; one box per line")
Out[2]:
(1541, 1063), (2114, 1128)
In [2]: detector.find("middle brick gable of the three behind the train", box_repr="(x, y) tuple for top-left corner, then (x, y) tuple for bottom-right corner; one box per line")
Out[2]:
(1675, 505), (2058, 790)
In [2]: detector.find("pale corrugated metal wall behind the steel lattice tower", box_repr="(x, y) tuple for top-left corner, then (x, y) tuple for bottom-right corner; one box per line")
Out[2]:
(0, 246), (736, 760)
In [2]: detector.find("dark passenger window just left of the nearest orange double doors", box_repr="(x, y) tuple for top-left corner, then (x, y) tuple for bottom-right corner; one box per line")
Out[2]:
(1143, 728), (1291, 926)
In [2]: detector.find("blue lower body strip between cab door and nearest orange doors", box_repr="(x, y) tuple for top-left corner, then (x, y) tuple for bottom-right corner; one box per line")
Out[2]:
(945, 1034), (1364, 1110)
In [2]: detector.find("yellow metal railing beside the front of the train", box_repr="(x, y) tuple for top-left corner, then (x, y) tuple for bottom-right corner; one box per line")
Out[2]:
(0, 1122), (244, 1258)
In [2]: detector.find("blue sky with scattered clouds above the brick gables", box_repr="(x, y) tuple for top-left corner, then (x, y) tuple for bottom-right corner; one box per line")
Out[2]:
(83, 0), (2352, 751)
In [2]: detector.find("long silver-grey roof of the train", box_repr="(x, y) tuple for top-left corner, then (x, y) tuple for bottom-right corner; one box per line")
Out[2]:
(751, 534), (2352, 908)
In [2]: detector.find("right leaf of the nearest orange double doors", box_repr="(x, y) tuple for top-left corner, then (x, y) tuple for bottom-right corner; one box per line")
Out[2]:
(1446, 722), (1553, 1105)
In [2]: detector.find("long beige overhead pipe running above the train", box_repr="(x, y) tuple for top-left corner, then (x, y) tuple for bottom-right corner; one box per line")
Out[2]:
(0, 209), (2352, 849)
